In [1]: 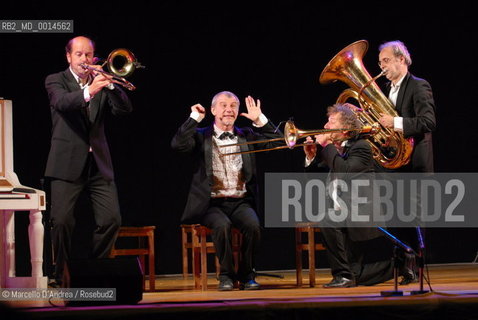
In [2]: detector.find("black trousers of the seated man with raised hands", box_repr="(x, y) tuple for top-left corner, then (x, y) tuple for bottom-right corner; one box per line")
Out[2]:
(202, 198), (261, 282)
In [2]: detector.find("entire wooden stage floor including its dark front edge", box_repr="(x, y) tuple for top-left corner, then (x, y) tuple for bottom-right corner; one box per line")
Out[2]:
(8, 263), (478, 320)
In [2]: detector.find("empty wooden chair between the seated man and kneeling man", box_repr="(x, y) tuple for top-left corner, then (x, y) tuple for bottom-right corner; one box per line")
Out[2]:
(295, 224), (325, 287)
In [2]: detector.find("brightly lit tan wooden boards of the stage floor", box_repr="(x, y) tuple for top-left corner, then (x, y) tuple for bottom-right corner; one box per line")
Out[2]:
(146, 263), (478, 303)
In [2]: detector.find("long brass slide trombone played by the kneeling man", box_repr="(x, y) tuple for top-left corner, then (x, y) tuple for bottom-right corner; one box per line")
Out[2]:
(219, 120), (380, 157)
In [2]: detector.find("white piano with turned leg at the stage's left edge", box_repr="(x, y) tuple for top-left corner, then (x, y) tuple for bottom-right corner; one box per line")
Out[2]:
(0, 99), (47, 288)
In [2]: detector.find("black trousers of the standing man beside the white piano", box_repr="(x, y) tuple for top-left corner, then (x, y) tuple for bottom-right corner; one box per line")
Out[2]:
(50, 153), (121, 281)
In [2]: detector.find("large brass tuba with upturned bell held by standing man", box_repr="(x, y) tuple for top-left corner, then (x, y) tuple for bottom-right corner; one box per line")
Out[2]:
(319, 40), (414, 169)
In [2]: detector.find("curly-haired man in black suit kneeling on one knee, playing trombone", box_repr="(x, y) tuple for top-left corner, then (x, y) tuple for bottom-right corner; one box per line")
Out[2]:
(304, 103), (414, 288)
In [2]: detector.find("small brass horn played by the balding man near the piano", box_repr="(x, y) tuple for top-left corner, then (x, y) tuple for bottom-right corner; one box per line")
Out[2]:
(80, 48), (145, 91)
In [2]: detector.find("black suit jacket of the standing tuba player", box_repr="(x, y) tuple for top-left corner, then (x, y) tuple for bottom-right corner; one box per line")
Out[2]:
(384, 73), (436, 172)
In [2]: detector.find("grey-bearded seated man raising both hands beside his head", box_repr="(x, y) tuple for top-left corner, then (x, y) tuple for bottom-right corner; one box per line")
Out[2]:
(171, 91), (281, 291)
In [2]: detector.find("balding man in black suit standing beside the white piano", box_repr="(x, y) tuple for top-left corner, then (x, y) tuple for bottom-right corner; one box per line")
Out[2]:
(45, 36), (133, 286)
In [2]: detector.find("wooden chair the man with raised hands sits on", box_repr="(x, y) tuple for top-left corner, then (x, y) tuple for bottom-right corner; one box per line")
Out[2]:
(181, 224), (242, 291)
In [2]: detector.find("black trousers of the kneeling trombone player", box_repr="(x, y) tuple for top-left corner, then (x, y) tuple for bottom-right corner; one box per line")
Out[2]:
(321, 228), (393, 285)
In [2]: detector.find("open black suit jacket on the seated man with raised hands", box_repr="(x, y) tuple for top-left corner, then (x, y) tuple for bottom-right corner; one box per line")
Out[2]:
(171, 118), (282, 223)
